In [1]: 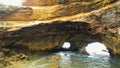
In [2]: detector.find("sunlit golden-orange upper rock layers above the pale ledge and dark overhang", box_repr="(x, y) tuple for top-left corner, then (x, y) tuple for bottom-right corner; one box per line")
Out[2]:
(0, 0), (117, 21)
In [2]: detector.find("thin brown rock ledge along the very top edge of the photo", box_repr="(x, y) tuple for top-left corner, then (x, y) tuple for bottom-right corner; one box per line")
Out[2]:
(23, 0), (112, 6)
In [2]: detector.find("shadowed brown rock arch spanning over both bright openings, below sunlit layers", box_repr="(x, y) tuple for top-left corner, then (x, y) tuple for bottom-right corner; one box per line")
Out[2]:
(0, 21), (120, 57)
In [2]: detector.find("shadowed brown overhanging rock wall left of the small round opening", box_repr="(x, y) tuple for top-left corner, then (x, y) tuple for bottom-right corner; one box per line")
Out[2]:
(0, 21), (93, 51)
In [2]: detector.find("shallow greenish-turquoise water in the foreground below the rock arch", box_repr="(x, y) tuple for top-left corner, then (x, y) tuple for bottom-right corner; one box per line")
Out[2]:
(7, 52), (120, 68)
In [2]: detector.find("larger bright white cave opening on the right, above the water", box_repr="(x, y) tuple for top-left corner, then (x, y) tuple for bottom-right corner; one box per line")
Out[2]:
(85, 42), (110, 57)
